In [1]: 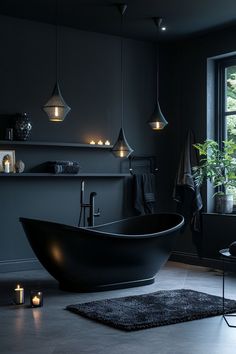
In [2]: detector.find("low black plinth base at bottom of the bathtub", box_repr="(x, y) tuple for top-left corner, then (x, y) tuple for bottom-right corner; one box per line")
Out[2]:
(59, 277), (155, 292)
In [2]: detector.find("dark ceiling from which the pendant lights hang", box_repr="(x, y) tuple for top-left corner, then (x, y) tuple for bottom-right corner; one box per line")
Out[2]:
(0, 0), (236, 41)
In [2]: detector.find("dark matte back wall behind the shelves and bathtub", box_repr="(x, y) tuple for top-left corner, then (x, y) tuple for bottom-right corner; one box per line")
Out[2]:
(0, 16), (168, 270)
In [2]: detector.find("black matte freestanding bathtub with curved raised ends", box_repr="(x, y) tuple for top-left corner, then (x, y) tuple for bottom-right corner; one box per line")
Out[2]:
(20, 213), (184, 291)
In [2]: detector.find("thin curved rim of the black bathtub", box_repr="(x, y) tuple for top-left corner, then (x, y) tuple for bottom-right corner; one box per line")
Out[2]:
(19, 212), (184, 239)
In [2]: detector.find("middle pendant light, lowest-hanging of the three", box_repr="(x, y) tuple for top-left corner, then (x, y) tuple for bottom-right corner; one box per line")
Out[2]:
(111, 4), (133, 158)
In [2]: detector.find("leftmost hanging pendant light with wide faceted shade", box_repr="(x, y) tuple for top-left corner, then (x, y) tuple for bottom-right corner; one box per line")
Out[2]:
(43, 0), (71, 122)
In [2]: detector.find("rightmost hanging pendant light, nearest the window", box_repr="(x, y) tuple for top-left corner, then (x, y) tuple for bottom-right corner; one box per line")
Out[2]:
(148, 17), (168, 130)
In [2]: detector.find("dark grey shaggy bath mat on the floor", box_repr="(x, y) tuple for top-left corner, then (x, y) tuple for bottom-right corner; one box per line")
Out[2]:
(66, 289), (236, 331)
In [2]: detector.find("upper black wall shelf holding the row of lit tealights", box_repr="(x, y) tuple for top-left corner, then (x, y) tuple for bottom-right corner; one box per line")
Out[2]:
(0, 140), (112, 150)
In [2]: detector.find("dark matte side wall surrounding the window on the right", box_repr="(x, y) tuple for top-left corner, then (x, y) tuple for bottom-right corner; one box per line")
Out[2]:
(160, 27), (236, 254)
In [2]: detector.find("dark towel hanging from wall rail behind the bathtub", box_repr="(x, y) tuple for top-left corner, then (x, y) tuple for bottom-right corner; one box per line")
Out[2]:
(133, 173), (156, 214)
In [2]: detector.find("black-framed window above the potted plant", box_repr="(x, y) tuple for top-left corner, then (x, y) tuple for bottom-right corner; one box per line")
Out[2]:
(216, 57), (236, 205)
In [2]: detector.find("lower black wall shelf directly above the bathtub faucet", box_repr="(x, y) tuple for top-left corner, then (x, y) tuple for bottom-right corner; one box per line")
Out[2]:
(0, 172), (130, 178)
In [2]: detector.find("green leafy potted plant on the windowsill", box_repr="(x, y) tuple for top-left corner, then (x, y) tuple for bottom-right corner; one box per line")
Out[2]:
(193, 140), (236, 213)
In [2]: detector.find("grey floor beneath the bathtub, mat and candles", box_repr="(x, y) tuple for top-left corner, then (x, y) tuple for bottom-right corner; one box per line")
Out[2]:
(0, 262), (236, 354)
